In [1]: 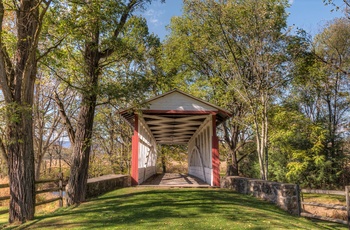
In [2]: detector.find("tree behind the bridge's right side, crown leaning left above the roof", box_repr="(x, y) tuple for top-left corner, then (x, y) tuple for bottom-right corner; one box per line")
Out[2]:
(163, 1), (247, 175)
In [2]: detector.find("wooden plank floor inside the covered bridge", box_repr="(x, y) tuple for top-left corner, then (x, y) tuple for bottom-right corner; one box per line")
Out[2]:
(140, 173), (210, 188)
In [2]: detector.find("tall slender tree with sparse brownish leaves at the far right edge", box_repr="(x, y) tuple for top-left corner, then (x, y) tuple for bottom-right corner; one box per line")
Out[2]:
(311, 18), (350, 149)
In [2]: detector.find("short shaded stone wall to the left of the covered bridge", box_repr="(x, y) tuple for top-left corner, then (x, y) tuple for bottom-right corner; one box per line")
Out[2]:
(86, 174), (131, 199)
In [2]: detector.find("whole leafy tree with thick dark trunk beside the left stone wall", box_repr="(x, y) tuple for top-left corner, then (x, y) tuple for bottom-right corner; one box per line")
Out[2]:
(50, 0), (163, 205)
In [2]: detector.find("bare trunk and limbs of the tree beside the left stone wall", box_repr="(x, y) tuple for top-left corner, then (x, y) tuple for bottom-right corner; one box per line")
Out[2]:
(59, 0), (143, 205)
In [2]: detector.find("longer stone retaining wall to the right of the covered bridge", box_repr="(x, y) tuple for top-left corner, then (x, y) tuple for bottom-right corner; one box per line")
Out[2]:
(221, 176), (300, 215)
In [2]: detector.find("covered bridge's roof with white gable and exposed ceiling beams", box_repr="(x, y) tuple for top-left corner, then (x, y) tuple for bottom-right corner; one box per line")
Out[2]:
(120, 89), (231, 144)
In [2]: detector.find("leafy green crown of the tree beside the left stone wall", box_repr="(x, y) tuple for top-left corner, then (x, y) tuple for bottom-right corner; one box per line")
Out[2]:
(41, 0), (167, 107)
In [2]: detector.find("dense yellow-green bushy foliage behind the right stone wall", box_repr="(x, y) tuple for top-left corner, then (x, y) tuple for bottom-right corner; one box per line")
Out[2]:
(270, 104), (341, 188)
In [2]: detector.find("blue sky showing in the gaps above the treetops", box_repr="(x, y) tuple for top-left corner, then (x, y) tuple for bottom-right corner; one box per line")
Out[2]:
(144, 0), (344, 40)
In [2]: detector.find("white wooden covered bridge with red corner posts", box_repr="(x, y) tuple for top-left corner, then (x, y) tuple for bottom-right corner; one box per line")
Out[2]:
(121, 89), (230, 186)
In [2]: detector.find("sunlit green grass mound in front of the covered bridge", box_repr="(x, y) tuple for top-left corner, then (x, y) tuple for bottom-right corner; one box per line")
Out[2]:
(0, 187), (347, 230)
